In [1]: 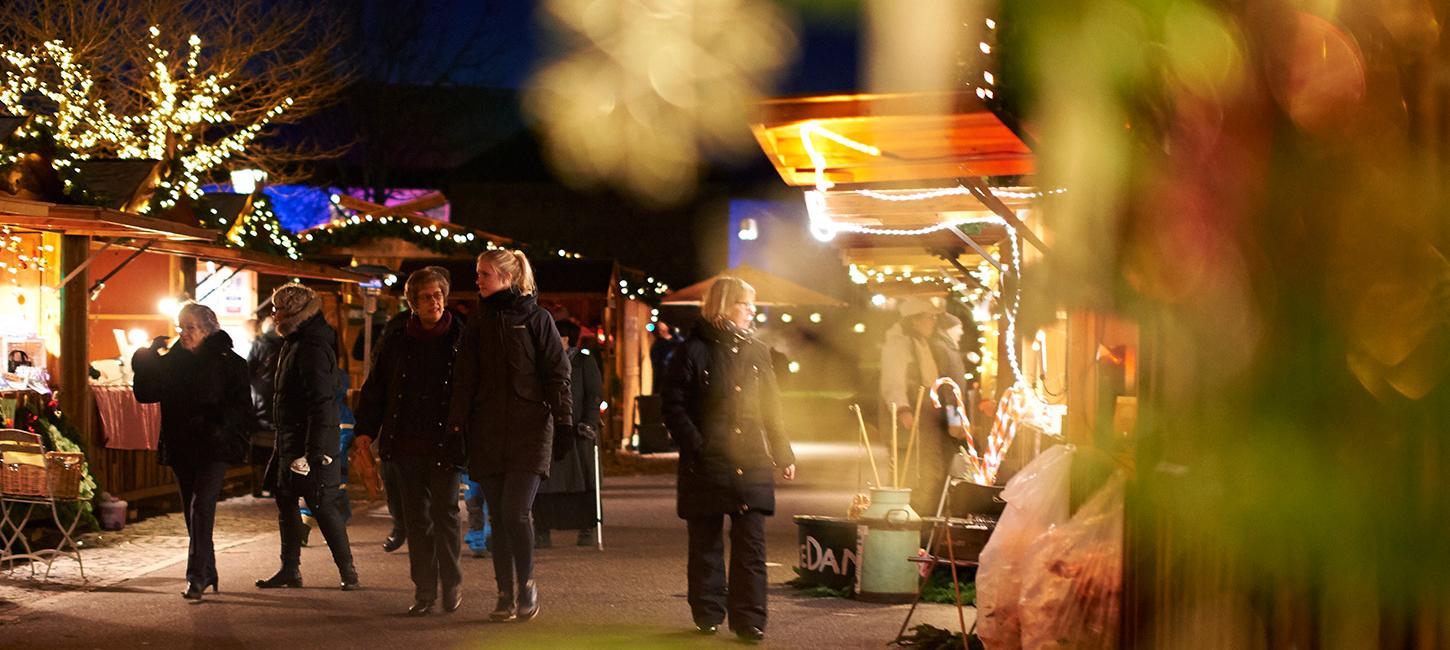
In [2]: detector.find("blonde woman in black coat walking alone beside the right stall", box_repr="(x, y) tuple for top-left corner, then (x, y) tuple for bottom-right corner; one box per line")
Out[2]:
(663, 277), (796, 641)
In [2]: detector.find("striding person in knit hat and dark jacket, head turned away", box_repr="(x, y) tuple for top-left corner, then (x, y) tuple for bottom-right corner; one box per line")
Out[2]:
(257, 284), (358, 591)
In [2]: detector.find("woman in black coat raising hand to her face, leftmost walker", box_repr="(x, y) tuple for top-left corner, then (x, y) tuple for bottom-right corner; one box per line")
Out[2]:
(131, 302), (252, 601)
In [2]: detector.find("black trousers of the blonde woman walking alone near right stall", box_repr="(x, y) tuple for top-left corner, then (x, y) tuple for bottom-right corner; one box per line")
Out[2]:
(686, 511), (767, 630)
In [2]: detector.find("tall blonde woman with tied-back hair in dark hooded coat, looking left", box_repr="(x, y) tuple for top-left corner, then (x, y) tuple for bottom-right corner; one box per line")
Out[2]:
(448, 250), (573, 621)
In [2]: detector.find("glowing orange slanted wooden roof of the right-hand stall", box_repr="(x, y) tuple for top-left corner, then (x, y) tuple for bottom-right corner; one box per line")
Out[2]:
(751, 91), (1035, 187)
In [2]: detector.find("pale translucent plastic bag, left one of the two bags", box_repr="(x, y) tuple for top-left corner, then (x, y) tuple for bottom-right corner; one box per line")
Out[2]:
(977, 445), (1076, 650)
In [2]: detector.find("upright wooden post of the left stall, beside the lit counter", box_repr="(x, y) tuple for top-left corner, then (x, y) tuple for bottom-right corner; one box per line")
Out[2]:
(58, 235), (91, 441)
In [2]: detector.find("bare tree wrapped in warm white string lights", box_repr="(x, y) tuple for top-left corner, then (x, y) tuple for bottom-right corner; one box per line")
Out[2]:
(0, 0), (349, 209)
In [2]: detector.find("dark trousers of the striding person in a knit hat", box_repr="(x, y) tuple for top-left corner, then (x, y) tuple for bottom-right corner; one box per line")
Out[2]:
(276, 463), (352, 572)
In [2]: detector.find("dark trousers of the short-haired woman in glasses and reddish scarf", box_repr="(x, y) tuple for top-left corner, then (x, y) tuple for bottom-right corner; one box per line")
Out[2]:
(387, 456), (463, 602)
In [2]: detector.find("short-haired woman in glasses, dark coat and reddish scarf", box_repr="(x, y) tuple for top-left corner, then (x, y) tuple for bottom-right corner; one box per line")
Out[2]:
(357, 267), (465, 617)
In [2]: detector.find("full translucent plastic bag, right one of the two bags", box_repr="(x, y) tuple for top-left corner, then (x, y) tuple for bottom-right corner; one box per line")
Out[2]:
(1018, 473), (1124, 650)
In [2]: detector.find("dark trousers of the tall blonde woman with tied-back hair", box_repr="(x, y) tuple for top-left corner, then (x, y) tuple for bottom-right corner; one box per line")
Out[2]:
(479, 472), (544, 595)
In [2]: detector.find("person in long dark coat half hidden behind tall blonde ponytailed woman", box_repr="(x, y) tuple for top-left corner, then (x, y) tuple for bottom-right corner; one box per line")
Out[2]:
(534, 321), (605, 548)
